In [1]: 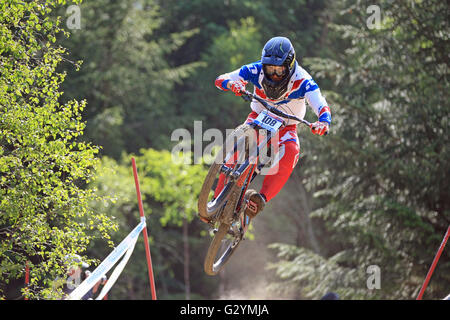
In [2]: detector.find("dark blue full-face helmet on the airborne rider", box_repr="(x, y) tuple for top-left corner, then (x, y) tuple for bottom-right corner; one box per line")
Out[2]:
(261, 37), (295, 100)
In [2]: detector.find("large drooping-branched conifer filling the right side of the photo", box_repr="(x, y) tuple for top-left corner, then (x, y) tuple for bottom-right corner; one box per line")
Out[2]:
(268, 1), (450, 299)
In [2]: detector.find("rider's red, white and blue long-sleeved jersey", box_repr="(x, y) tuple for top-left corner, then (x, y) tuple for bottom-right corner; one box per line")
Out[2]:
(215, 61), (331, 125)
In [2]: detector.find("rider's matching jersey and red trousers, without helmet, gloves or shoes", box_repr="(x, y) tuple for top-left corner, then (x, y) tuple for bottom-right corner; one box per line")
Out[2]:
(215, 61), (331, 201)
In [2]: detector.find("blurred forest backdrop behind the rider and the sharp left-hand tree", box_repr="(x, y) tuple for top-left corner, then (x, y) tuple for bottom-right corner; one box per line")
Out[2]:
(1, 0), (450, 300)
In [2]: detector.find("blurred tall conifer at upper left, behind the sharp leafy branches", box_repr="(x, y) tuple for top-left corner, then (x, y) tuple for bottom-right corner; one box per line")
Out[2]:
(60, 0), (202, 159)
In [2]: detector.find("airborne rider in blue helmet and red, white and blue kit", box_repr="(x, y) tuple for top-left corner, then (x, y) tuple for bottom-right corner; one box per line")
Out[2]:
(215, 37), (331, 217)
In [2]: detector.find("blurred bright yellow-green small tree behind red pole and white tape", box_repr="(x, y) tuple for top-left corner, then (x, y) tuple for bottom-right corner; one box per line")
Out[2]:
(91, 149), (215, 299)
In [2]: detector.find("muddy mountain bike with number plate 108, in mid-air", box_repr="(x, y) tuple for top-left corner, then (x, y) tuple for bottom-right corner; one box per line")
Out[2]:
(198, 91), (312, 275)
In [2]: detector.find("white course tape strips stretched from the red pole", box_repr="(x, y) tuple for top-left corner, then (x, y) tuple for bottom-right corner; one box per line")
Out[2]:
(67, 218), (146, 300)
